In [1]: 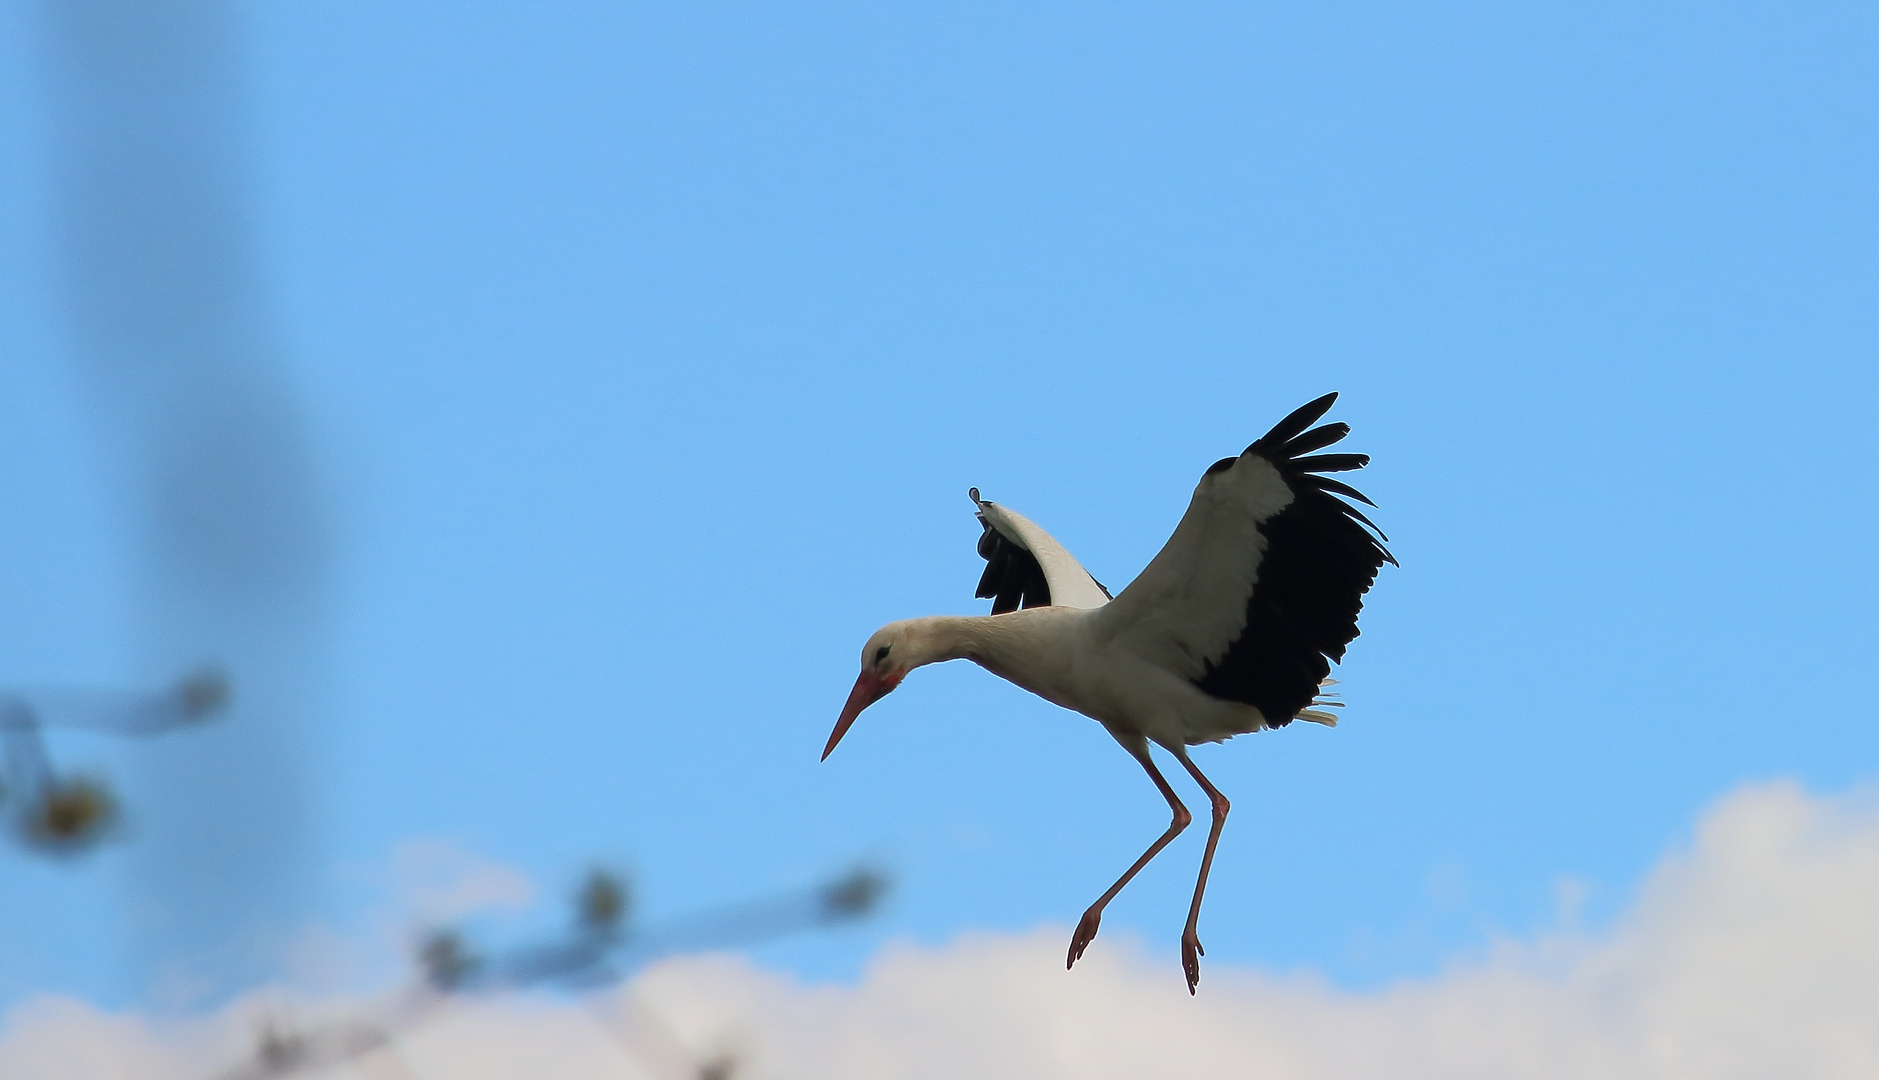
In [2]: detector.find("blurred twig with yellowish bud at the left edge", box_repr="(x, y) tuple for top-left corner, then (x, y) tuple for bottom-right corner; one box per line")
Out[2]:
(0, 671), (229, 855)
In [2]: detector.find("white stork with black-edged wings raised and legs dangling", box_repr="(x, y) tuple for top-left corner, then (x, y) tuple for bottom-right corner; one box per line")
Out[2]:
(823, 394), (1396, 994)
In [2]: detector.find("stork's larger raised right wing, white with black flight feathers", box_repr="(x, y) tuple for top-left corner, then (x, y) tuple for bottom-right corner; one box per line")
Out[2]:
(1101, 394), (1396, 727)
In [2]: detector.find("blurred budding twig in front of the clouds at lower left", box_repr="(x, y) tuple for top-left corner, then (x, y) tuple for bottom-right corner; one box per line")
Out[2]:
(218, 866), (889, 1080)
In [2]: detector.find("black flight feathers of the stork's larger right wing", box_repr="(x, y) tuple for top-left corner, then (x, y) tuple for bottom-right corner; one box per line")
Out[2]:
(1195, 394), (1396, 727)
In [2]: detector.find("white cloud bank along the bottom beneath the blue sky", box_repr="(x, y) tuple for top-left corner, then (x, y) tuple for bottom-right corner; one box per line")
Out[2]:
(0, 783), (1879, 1080)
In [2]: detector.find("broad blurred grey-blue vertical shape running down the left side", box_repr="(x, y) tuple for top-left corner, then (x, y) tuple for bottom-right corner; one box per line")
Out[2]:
(38, 0), (325, 1003)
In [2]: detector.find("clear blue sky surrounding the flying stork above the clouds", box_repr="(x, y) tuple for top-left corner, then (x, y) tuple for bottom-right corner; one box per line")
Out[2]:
(0, 2), (1879, 1001)
